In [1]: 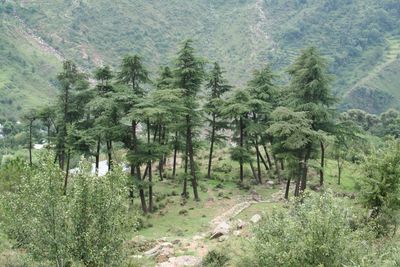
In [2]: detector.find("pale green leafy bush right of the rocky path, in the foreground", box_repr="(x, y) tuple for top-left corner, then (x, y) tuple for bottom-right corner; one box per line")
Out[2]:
(242, 193), (369, 267)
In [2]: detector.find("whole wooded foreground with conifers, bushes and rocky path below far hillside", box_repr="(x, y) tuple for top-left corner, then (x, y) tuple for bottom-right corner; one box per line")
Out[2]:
(0, 36), (400, 266)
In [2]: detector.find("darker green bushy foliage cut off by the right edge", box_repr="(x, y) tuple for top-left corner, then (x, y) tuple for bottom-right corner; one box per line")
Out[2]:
(361, 141), (400, 235)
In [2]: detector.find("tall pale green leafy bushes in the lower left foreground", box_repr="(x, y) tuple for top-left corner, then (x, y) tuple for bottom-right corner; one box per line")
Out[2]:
(2, 156), (131, 266)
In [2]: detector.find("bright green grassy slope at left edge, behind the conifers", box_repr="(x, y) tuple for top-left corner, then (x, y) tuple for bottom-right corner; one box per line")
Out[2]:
(0, 11), (60, 118)
